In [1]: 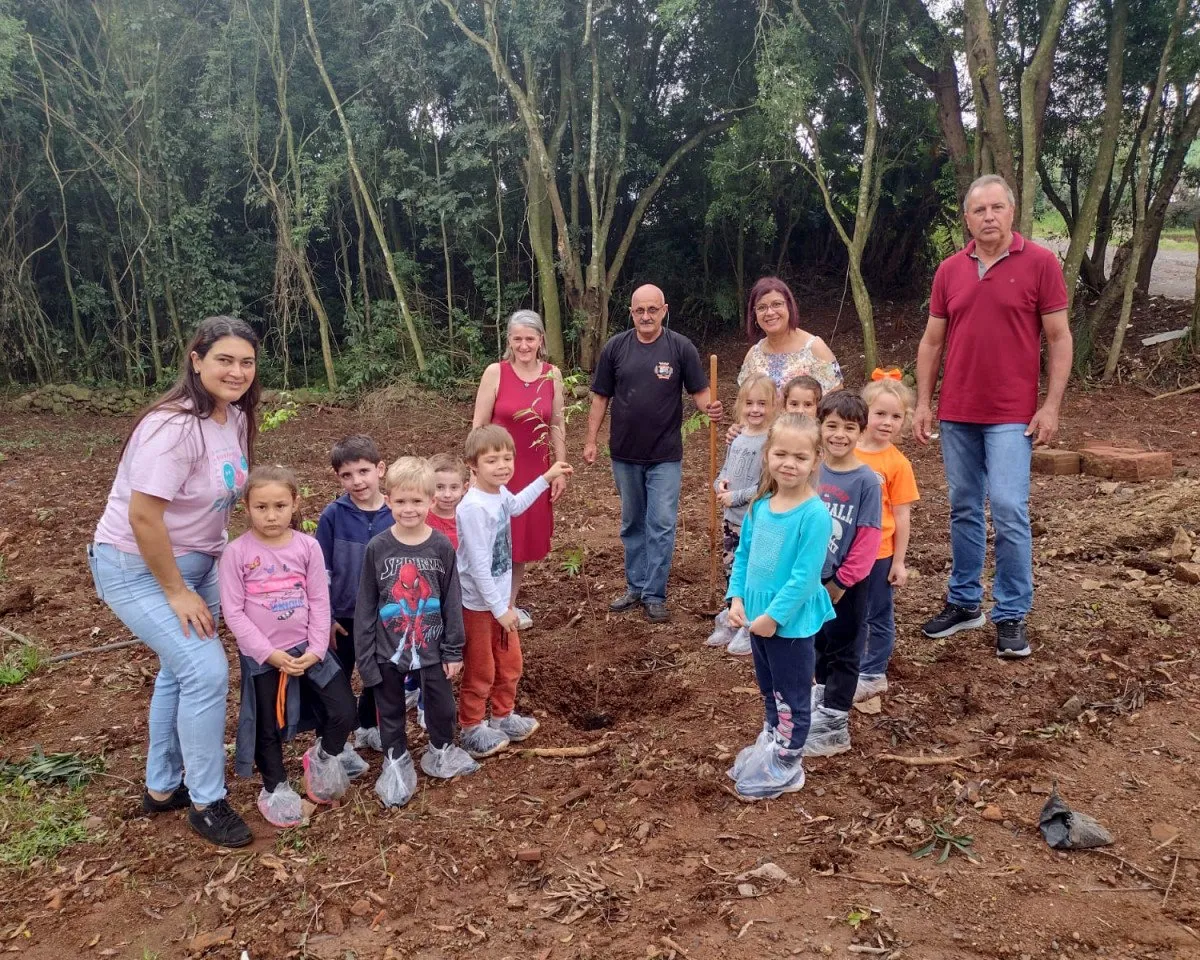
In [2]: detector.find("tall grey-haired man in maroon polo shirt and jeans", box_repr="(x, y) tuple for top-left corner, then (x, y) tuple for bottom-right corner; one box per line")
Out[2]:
(912, 175), (1072, 659)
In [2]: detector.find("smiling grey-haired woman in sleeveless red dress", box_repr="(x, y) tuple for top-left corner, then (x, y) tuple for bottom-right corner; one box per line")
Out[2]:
(472, 310), (566, 630)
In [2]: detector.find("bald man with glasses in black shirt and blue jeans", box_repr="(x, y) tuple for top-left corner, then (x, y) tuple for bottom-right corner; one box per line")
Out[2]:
(583, 283), (721, 623)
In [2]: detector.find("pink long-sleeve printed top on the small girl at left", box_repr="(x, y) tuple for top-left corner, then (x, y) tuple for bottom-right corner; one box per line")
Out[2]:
(217, 530), (331, 664)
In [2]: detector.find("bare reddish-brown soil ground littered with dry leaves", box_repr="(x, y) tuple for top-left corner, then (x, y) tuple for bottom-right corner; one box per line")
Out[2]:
(0, 307), (1200, 960)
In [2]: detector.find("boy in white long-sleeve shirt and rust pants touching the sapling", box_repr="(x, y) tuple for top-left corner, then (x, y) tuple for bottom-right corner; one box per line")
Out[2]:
(455, 424), (571, 760)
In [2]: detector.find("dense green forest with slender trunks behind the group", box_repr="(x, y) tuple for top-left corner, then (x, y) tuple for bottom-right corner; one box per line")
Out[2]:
(0, 0), (1200, 391)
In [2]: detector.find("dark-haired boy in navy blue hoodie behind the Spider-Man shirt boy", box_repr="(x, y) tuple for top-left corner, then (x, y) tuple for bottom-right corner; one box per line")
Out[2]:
(317, 434), (392, 751)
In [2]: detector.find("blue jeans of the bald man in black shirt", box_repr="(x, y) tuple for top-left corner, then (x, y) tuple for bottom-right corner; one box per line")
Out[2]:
(612, 460), (683, 604)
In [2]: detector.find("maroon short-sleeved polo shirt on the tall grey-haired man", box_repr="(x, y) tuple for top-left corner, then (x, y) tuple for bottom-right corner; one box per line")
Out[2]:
(929, 230), (1067, 424)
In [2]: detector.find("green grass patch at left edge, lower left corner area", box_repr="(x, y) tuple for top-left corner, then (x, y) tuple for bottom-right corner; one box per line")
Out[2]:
(0, 780), (88, 870)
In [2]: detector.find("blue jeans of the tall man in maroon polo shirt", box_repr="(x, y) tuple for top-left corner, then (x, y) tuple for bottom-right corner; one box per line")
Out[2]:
(941, 420), (1033, 622)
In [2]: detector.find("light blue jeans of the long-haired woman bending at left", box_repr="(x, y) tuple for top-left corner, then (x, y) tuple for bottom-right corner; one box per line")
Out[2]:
(88, 544), (229, 806)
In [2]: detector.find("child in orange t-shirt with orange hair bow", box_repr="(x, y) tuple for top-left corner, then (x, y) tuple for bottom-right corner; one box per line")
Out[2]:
(854, 370), (920, 702)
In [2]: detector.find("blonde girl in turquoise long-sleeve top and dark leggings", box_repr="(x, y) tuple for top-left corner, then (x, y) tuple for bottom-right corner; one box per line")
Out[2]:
(726, 414), (834, 800)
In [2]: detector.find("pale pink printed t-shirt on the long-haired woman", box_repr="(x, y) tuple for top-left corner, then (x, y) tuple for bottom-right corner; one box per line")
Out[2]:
(96, 407), (248, 557)
